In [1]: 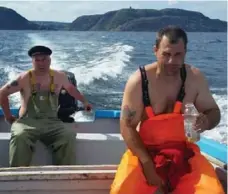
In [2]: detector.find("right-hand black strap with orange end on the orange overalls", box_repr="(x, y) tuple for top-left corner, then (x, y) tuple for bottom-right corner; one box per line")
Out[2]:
(173, 64), (187, 113)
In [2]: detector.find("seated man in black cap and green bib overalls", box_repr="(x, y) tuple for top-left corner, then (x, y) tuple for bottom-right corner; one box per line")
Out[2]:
(0, 46), (91, 167)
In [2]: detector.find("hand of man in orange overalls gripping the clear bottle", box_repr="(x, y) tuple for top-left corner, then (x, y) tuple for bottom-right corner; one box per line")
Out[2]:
(194, 113), (210, 133)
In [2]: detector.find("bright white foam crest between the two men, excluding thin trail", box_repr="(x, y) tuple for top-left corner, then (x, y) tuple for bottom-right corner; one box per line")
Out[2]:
(70, 43), (133, 84)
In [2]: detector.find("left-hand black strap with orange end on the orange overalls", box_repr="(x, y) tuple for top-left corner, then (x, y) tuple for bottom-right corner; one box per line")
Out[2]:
(139, 66), (154, 117)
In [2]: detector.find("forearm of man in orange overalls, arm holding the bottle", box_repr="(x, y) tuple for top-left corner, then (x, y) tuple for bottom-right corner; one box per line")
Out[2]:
(204, 108), (221, 130)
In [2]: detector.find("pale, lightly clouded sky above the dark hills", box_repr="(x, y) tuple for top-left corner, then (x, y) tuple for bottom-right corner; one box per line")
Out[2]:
(0, 0), (227, 22)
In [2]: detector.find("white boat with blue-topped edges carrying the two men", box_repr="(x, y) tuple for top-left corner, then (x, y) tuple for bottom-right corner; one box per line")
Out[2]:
(0, 109), (227, 194)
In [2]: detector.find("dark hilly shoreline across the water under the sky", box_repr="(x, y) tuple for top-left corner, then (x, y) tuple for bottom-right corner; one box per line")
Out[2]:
(0, 7), (227, 32)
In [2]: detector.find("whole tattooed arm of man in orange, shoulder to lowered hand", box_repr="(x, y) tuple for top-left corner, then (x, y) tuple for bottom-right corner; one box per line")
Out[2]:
(120, 71), (164, 188)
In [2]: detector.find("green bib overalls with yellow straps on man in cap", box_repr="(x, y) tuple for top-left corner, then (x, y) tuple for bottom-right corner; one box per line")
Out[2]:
(9, 70), (76, 166)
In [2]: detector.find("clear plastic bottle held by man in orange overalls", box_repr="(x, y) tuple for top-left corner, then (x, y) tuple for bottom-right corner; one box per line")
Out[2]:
(184, 103), (200, 142)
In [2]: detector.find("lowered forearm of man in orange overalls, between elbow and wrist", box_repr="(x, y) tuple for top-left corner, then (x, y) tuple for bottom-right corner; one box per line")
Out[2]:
(121, 125), (151, 163)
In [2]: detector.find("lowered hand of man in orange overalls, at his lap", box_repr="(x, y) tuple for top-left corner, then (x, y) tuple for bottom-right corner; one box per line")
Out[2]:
(141, 160), (163, 189)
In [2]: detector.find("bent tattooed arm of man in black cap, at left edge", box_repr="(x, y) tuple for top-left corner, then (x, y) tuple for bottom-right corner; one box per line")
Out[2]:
(0, 76), (22, 120)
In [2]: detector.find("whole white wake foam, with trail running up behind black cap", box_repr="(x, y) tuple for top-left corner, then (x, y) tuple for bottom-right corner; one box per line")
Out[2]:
(28, 33), (133, 84)
